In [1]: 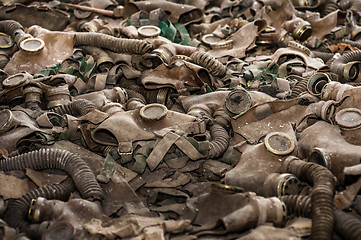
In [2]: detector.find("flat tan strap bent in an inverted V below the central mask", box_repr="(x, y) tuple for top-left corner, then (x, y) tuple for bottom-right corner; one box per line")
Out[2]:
(146, 131), (205, 171)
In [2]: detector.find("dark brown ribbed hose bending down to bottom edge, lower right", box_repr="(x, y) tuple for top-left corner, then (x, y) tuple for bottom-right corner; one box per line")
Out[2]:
(281, 156), (335, 240)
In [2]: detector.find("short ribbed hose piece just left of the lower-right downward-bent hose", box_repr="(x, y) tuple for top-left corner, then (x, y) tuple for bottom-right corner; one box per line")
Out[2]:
(279, 195), (311, 218)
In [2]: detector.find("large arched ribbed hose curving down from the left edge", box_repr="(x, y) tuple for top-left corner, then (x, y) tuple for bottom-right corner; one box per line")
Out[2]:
(0, 149), (103, 200)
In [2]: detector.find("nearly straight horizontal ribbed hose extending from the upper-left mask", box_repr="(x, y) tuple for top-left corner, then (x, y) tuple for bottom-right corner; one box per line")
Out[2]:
(74, 33), (152, 54)
